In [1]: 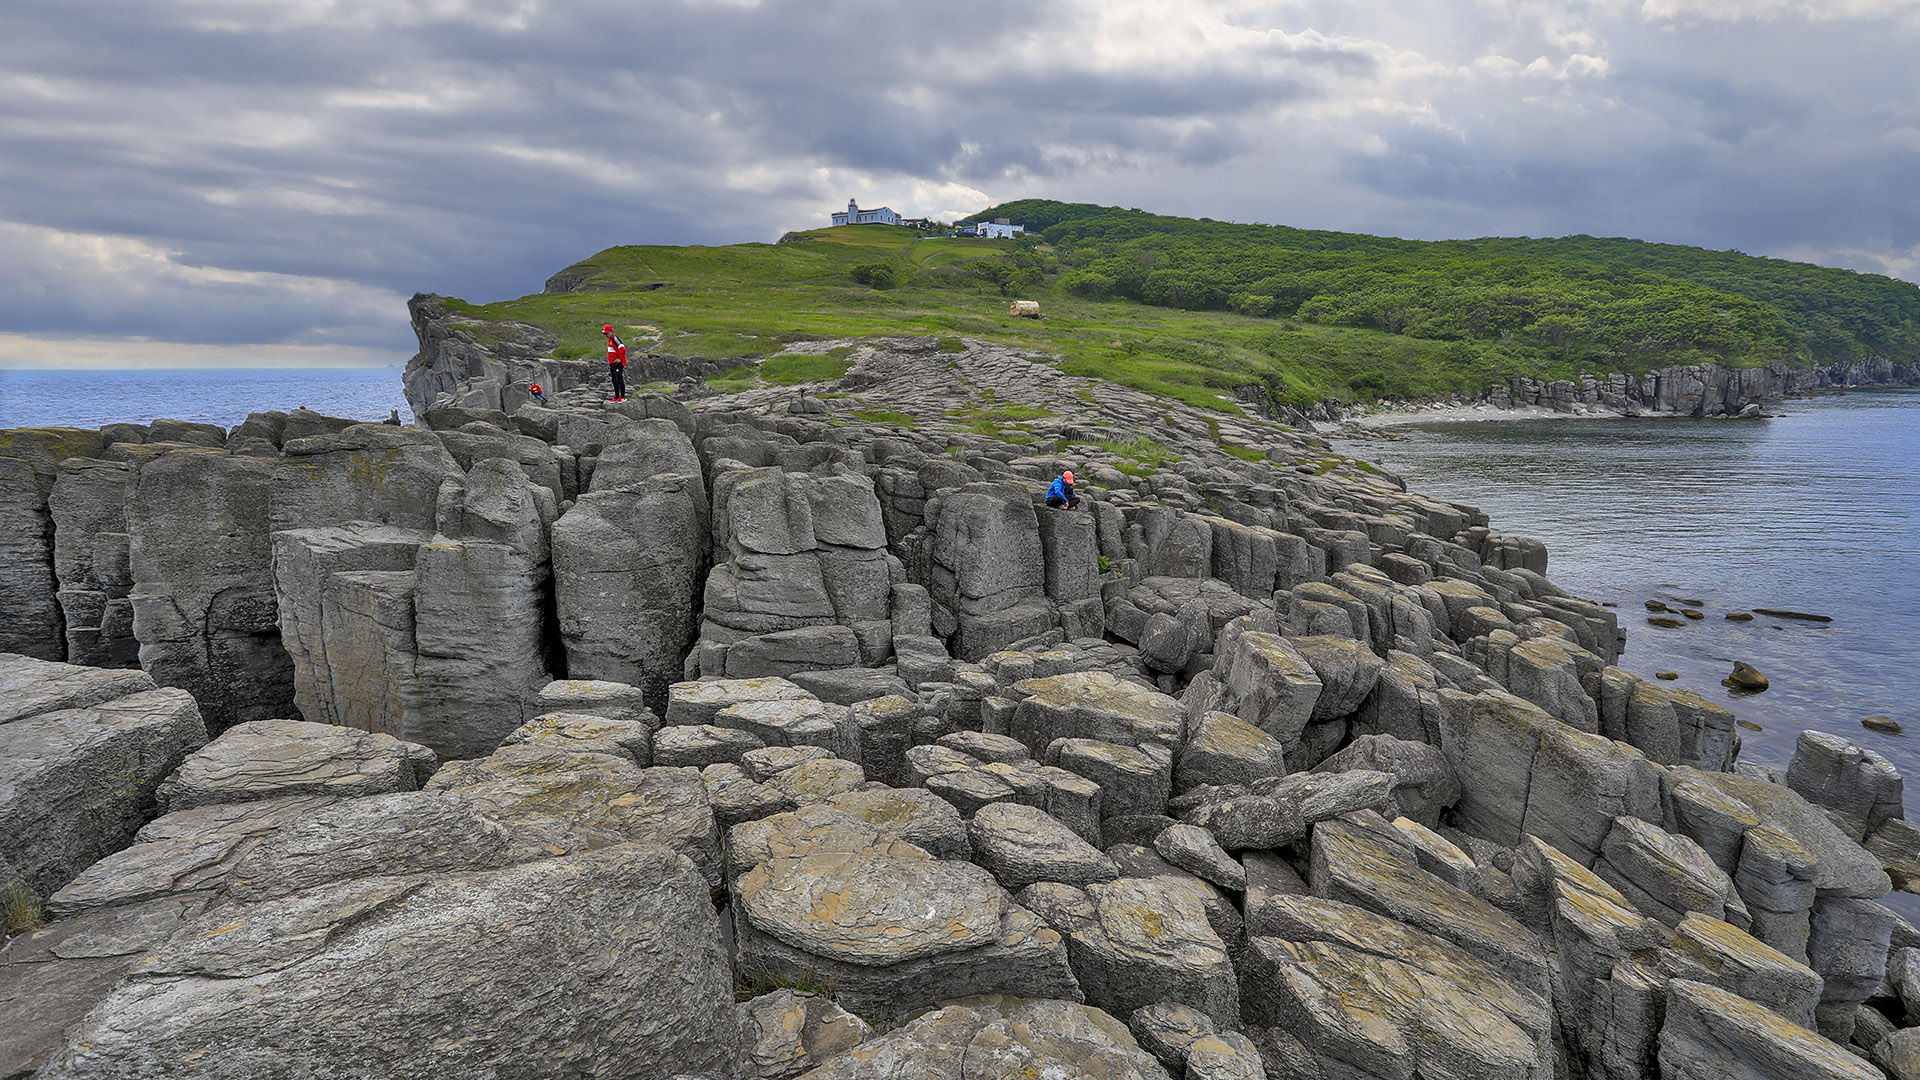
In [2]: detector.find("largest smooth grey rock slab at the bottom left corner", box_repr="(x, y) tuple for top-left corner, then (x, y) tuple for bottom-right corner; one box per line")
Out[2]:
(31, 844), (737, 1080)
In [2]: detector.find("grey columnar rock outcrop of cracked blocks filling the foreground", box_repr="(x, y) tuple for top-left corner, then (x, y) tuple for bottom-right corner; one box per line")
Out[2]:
(0, 322), (1920, 1080)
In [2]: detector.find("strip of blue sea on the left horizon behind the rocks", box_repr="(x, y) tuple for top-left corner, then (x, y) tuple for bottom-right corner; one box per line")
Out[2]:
(0, 367), (413, 427)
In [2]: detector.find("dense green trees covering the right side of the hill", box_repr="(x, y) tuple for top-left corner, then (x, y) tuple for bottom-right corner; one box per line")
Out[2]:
(977, 200), (1920, 367)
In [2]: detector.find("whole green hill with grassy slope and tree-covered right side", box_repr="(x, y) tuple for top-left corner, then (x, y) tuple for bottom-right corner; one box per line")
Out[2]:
(435, 200), (1920, 411)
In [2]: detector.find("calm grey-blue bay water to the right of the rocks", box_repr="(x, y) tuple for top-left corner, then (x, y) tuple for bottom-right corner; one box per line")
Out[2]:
(1340, 390), (1920, 791)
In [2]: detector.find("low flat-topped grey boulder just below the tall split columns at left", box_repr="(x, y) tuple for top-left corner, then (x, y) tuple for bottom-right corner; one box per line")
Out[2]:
(157, 721), (436, 813)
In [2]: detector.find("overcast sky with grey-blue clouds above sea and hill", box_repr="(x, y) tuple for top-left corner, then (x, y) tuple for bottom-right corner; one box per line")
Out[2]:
(0, 0), (1920, 367)
